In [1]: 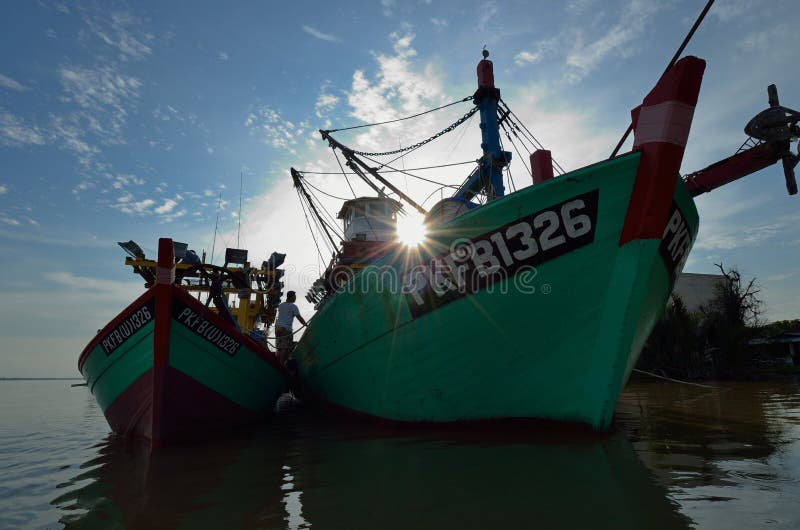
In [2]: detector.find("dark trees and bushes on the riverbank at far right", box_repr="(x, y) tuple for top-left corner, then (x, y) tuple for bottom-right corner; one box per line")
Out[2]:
(637, 264), (800, 380)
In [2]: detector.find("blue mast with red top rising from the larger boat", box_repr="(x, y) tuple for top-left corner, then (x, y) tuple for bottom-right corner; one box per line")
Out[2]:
(454, 50), (511, 200)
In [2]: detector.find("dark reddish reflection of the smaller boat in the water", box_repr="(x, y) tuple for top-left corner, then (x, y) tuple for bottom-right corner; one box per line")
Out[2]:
(52, 431), (285, 529)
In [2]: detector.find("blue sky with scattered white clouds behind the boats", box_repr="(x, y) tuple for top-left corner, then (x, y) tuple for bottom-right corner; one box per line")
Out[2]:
(0, 0), (800, 377)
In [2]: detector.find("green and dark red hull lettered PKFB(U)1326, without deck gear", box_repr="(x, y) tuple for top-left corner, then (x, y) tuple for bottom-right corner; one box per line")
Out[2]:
(78, 285), (285, 445)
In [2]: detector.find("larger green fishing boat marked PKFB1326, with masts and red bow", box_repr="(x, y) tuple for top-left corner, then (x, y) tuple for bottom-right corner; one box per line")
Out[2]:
(292, 52), (800, 431)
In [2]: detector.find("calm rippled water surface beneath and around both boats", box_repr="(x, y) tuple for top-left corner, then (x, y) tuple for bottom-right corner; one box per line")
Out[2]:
(0, 381), (800, 529)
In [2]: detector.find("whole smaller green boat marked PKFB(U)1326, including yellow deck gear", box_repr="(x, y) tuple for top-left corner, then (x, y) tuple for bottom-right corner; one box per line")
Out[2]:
(78, 238), (286, 446)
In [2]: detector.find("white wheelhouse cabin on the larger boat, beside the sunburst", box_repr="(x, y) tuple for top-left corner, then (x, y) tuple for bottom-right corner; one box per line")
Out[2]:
(336, 197), (403, 241)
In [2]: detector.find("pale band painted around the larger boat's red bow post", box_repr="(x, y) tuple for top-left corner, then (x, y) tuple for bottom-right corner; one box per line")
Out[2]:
(633, 101), (694, 148)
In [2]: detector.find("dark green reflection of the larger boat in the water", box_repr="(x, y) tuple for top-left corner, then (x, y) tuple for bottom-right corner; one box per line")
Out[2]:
(287, 420), (690, 529)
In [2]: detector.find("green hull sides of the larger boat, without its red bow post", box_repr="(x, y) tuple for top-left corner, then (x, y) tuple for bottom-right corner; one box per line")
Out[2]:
(295, 153), (698, 431)
